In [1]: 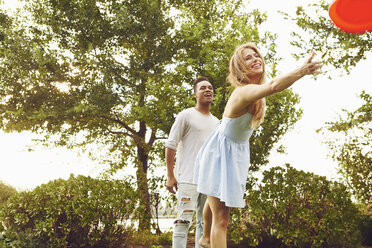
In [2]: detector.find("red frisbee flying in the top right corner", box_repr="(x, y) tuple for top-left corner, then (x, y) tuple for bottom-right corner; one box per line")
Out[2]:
(328, 0), (372, 34)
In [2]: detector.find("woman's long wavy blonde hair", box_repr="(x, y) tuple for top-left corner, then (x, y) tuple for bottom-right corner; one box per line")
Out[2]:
(227, 42), (266, 129)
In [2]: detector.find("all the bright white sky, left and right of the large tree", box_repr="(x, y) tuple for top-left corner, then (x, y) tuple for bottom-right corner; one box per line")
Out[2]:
(0, 0), (372, 190)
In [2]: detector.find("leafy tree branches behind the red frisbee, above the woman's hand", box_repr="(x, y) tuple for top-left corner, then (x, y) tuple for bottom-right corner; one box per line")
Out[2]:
(283, 0), (372, 73)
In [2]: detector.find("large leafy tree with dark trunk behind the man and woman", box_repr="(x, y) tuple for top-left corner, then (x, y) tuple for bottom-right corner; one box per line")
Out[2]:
(0, 0), (301, 229)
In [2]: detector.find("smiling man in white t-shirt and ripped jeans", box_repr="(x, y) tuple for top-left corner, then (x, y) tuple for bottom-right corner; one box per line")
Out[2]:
(165, 77), (219, 248)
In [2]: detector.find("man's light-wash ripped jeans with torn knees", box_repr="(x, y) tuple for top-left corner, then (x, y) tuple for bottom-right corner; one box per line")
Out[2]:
(172, 183), (207, 248)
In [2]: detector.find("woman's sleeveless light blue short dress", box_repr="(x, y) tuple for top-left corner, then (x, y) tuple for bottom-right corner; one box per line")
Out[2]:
(194, 112), (253, 208)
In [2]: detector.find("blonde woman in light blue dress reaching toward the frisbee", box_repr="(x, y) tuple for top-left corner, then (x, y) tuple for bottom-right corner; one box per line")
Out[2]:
(194, 43), (321, 248)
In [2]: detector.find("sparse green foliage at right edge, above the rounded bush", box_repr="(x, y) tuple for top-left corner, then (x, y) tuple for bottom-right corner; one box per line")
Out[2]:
(319, 92), (372, 206)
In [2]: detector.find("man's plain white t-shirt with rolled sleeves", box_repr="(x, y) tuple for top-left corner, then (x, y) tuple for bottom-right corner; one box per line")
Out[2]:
(165, 107), (219, 184)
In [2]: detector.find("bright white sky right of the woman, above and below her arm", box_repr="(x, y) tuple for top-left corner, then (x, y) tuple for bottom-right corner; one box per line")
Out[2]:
(249, 0), (372, 180)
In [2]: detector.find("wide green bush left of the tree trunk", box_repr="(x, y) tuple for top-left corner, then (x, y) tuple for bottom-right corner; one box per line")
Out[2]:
(0, 176), (137, 248)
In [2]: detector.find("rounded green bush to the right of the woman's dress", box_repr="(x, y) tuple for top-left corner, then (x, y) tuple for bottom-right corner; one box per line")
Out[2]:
(230, 165), (360, 248)
